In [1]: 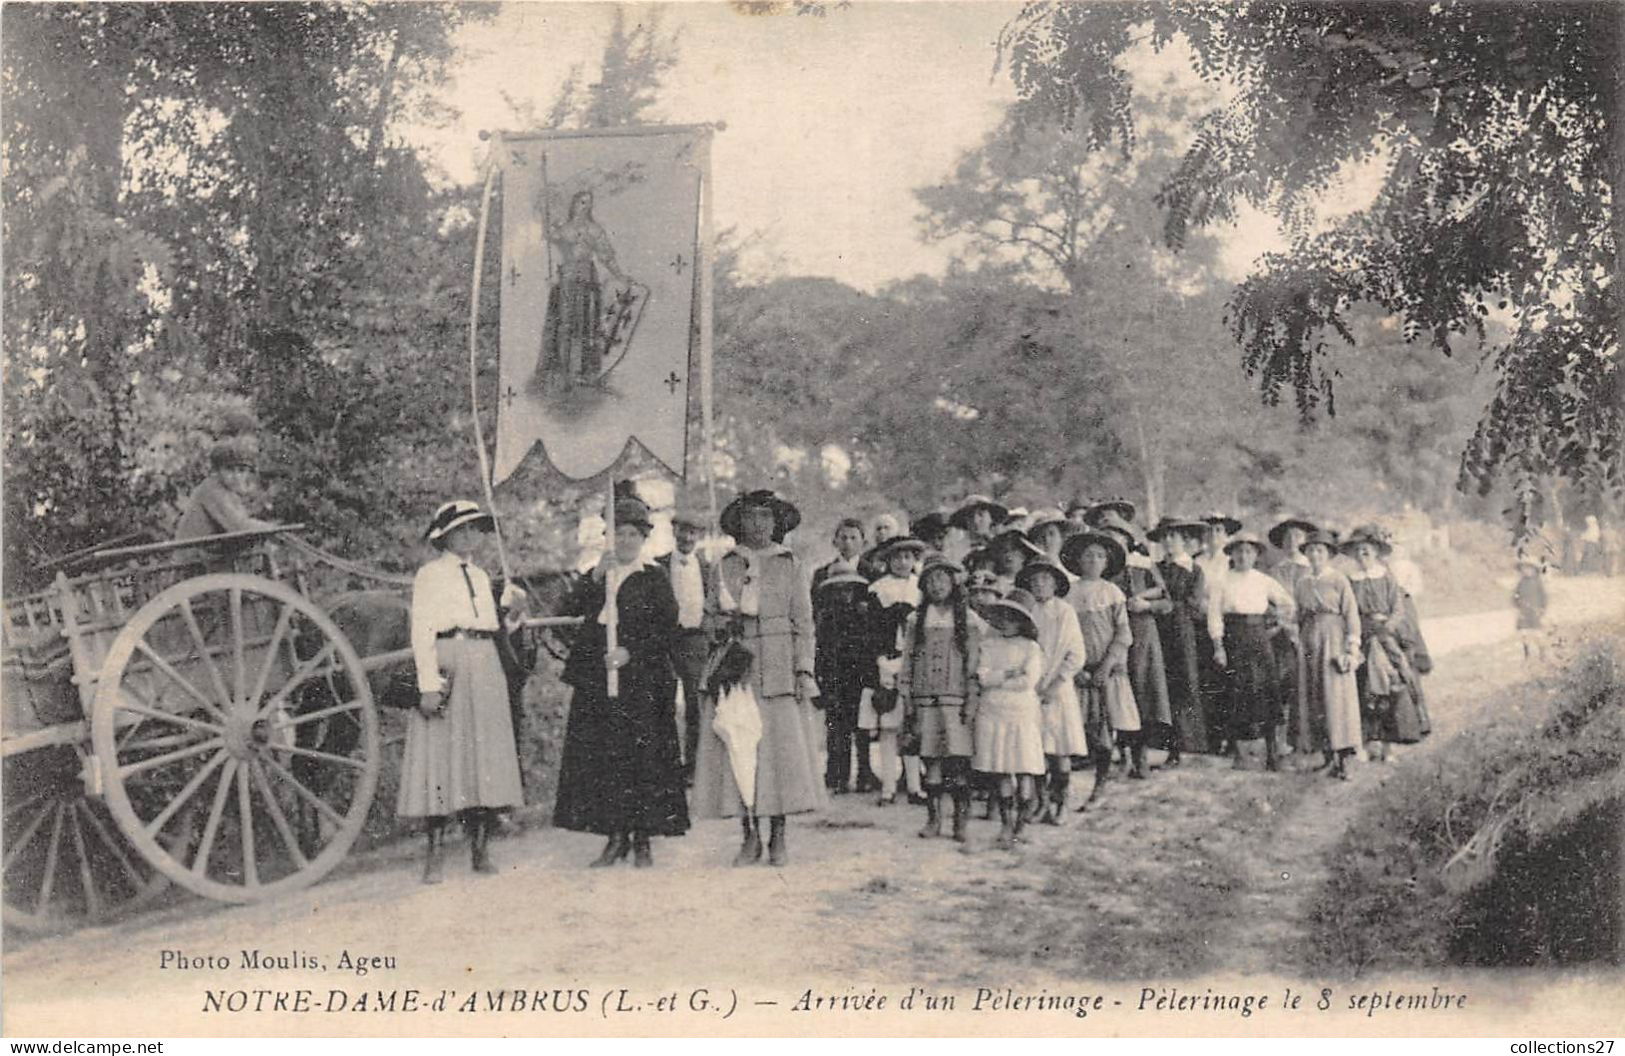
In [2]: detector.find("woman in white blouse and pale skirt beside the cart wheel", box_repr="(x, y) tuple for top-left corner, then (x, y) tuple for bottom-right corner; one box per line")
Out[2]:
(406, 502), (523, 884)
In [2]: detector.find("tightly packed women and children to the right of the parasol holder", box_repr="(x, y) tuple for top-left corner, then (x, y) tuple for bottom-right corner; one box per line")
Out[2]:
(811, 496), (1432, 846)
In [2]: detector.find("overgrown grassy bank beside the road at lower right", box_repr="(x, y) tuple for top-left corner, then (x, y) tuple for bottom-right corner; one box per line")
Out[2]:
(1313, 627), (1625, 972)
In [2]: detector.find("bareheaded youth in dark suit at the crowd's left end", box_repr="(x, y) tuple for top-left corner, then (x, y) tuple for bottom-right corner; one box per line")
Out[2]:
(813, 517), (879, 793)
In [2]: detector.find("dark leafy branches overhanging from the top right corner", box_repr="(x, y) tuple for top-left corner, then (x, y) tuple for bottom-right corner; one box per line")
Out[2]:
(1001, 0), (1625, 530)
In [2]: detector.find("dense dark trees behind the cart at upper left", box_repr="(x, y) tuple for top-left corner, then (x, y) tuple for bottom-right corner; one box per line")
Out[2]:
(3, 3), (481, 577)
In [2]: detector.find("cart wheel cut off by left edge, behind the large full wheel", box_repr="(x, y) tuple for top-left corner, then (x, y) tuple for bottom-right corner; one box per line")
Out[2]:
(0, 744), (169, 933)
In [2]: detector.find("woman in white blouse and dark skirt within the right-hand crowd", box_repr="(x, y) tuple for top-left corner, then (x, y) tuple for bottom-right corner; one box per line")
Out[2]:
(1207, 531), (1295, 770)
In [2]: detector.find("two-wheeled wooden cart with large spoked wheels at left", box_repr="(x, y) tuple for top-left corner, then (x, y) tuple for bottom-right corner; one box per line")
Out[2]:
(0, 528), (380, 929)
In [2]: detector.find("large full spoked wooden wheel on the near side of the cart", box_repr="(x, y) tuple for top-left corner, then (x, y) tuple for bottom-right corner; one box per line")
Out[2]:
(91, 573), (380, 902)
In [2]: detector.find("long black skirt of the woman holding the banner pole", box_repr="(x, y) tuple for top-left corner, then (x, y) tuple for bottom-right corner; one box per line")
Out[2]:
(553, 653), (689, 837)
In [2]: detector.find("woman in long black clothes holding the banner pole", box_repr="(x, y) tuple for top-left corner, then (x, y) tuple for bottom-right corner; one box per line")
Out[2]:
(553, 499), (689, 866)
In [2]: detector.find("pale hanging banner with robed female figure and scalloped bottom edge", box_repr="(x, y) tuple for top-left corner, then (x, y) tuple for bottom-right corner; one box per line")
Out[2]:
(492, 128), (710, 483)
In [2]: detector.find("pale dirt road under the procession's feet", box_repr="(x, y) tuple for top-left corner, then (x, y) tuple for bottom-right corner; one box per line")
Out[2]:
(3, 580), (1625, 1022)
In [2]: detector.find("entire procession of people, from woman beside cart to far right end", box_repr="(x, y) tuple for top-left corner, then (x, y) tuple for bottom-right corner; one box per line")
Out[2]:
(398, 489), (1449, 882)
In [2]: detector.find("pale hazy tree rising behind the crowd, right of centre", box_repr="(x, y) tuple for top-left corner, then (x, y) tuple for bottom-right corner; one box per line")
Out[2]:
(915, 93), (1256, 518)
